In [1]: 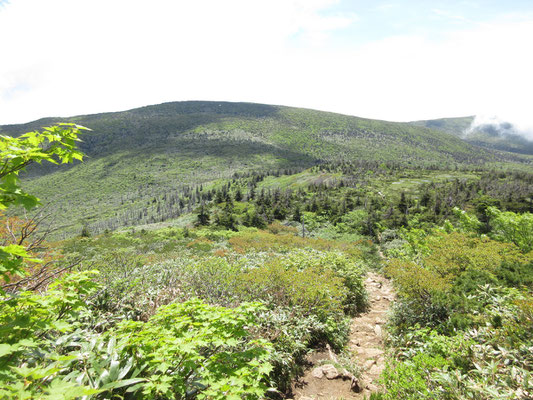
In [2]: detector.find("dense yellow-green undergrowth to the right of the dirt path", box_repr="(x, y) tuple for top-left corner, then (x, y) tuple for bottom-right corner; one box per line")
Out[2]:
(374, 209), (533, 400)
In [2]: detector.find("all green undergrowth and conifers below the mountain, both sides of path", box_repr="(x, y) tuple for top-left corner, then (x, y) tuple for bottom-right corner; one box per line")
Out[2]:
(0, 127), (533, 399)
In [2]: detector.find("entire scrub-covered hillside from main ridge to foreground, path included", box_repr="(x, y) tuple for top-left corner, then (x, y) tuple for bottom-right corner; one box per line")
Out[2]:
(0, 112), (533, 400)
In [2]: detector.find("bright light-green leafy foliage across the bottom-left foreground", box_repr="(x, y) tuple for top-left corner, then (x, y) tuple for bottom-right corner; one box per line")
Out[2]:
(0, 284), (271, 399)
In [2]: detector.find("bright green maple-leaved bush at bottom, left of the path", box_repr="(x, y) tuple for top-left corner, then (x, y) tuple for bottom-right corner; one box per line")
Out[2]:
(110, 300), (271, 399)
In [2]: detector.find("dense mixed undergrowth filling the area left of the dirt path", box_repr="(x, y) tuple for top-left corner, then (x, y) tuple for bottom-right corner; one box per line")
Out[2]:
(1, 220), (372, 398)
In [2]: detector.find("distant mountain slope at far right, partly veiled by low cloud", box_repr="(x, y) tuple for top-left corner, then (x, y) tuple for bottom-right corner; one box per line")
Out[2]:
(411, 116), (533, 155)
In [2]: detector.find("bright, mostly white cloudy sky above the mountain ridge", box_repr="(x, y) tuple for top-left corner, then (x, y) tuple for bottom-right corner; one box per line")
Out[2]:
(0, 0), (533, 139)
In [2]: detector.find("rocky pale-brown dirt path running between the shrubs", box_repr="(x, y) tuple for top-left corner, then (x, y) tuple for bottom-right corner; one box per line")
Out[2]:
(293, 272), (394, 400)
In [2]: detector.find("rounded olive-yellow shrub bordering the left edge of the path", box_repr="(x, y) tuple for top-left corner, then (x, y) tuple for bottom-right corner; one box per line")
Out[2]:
(235, 250), (367, 391)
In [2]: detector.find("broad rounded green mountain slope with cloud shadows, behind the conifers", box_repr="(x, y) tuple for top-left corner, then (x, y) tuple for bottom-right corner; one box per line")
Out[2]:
(0, 101), (528, 236)
